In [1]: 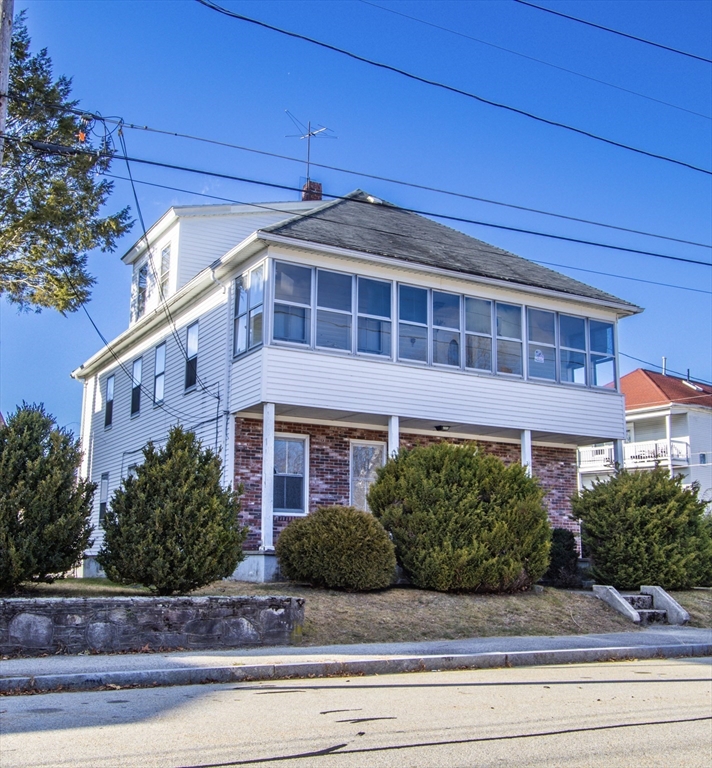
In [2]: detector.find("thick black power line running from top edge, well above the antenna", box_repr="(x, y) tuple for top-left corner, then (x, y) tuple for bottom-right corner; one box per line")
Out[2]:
(196, 0), (712, 176)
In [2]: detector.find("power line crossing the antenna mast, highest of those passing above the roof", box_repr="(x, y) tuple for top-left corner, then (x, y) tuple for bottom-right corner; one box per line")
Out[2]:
(10, 94), (712, 248)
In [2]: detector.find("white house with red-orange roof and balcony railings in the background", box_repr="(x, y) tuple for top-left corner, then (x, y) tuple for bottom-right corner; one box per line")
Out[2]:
(579, 368), (712, 501)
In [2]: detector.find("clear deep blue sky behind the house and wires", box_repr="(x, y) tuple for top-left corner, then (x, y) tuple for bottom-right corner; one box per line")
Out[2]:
(0, 0), (712, 431)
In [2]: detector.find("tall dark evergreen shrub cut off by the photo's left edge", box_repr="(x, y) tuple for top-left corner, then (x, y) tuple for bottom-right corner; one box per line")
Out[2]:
(0, 403), (95, 592)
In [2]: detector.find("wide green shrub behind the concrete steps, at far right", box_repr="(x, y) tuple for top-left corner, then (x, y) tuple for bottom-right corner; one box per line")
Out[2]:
(573, 467), (712, 589)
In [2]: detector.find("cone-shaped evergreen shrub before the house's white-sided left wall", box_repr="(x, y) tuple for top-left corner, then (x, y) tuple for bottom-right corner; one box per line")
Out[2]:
(97, 427), (247, 595)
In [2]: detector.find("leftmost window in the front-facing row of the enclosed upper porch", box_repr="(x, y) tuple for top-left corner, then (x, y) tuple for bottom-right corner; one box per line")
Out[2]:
(273, 262), (312, 344)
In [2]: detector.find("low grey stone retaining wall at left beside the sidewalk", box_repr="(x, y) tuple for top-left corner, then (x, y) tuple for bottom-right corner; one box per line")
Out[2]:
(0, 597), (304, 656)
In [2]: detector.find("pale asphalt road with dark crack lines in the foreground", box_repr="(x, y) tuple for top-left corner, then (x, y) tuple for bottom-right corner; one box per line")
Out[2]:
(0, 658), (712, 768)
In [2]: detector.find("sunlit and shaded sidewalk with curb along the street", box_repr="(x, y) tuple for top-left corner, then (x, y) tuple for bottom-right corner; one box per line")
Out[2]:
(0, 626), (712, 693)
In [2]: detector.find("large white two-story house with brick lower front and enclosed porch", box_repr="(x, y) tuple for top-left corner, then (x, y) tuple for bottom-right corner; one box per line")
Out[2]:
(73, 188), (641, 580)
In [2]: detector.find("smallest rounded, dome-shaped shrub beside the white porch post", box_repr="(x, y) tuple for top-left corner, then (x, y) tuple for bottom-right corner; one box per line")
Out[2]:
(276, 506), (396, 592)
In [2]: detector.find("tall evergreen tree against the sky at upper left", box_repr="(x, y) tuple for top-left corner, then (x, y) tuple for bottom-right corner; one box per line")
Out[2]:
(0, 14), (131, 312)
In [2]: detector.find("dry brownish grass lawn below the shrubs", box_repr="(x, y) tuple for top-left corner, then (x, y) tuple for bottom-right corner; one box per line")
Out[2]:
(21, 579), (712, 645)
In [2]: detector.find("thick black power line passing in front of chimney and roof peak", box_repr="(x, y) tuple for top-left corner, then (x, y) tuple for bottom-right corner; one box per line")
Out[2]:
(11, 134), (712, 267)
